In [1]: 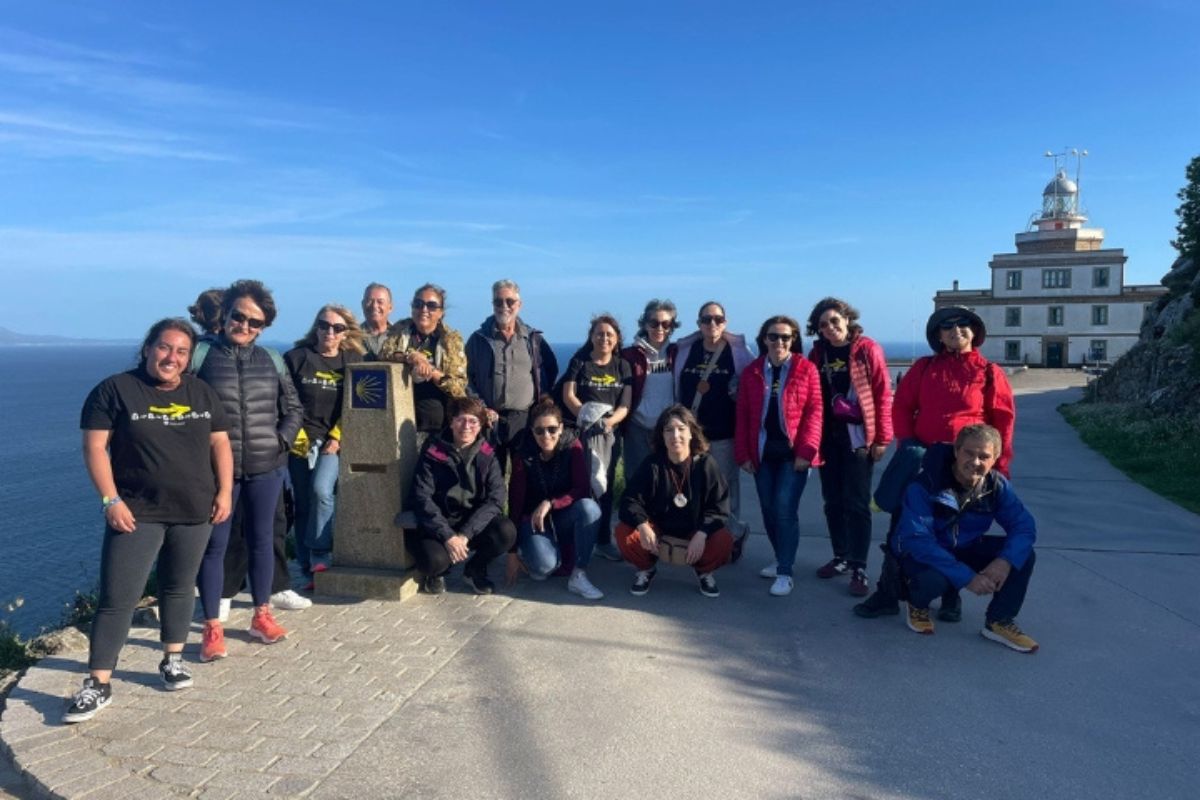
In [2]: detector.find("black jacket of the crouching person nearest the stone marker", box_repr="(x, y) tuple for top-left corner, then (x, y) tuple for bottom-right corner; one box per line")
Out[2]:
(413, 432), (505, 543)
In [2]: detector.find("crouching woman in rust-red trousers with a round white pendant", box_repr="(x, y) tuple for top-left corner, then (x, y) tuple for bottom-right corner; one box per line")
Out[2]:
(617, 403), (733, 597)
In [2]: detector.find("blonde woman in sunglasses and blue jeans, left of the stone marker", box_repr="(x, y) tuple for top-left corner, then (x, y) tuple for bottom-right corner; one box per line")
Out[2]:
(283, 305), (366, 577)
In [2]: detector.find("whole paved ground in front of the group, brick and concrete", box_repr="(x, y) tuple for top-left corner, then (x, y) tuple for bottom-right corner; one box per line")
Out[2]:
(0, 381), (1200, 800)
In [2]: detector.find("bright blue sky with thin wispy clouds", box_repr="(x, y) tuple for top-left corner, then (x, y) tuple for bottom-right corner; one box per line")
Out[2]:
(0, 0), (1200, 341)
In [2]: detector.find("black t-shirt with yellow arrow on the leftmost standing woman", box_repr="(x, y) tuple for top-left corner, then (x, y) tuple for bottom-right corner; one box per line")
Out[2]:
(79, 369), (229, 524)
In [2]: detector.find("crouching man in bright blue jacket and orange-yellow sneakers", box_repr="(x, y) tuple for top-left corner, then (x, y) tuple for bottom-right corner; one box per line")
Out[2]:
(895, 425), (1038, 652)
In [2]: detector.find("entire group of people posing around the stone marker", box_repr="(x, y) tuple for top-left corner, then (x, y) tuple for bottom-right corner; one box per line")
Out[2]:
(64, 281), (1037, 722)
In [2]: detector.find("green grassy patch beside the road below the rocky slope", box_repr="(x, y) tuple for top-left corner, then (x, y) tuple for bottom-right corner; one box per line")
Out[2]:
(1058, 403), (1200, 513)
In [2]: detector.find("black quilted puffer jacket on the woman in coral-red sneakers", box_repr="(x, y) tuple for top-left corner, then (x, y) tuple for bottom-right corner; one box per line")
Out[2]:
(196, 341), (304, 477)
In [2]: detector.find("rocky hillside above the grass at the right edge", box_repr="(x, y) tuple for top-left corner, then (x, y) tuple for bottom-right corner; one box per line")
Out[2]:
(1090, 258), (1200, 417)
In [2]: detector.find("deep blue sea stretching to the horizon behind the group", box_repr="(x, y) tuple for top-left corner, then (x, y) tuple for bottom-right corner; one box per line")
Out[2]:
(0, 335), (924, 636)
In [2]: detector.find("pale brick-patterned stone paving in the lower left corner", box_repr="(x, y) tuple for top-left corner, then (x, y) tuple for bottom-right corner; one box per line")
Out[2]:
(0, 594), (511, 799)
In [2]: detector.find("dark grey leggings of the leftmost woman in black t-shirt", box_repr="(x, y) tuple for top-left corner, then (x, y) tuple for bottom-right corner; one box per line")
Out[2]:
(88, 522), (212, 669)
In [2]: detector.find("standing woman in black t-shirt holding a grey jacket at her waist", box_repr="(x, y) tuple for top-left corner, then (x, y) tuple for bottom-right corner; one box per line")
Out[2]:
(563, 314), (634, 561)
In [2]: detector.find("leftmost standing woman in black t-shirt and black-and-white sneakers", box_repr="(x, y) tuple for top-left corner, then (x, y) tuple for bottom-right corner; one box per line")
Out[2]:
(62, 319), (233, 722)
